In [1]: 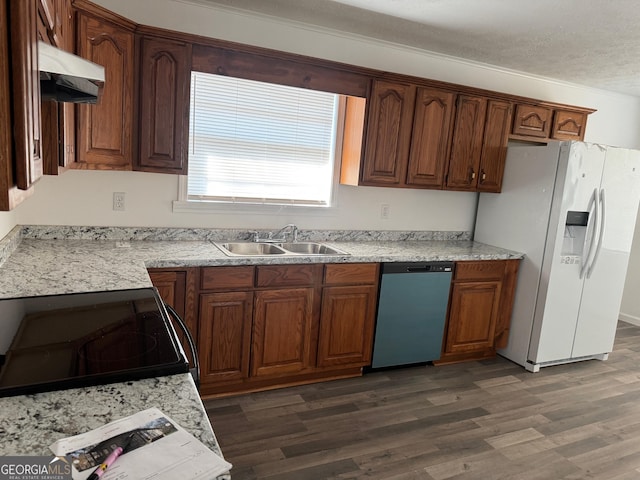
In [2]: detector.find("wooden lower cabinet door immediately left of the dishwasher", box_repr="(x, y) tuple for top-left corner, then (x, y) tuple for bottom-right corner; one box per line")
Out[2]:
(317, 286), (377, 367)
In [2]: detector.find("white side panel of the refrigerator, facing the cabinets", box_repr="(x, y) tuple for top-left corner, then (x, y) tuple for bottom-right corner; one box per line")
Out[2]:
(474, 142), (560, 366)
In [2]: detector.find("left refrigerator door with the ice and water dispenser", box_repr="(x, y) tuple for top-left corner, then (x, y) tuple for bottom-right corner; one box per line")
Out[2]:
(529, 142), (606, 364)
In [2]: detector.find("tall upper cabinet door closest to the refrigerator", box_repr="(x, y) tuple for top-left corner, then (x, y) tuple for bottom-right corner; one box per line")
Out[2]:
(478, 100), (512, 193)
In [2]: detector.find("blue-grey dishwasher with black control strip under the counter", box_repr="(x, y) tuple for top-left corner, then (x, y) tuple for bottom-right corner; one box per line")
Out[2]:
(371, 262), (453, 368)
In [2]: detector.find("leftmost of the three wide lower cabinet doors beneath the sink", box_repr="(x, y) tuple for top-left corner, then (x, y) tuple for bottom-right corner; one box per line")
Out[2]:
(198, 292), (253, 384)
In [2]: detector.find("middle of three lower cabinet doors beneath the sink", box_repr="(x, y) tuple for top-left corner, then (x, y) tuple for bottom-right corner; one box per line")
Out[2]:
(251, 288), (315, 377)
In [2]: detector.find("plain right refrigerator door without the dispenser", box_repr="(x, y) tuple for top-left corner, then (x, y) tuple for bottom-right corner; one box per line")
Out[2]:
(572, 147), (640, 357)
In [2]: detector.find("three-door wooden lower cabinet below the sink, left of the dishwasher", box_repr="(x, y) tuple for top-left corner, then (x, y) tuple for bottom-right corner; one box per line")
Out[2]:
(192, 263), (379, 396)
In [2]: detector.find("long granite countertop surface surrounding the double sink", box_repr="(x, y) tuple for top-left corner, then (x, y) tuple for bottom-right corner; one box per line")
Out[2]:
(0, 227), (522, 298)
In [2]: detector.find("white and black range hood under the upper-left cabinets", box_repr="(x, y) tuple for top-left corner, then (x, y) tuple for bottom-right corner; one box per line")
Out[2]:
(38, 41), (104, 103)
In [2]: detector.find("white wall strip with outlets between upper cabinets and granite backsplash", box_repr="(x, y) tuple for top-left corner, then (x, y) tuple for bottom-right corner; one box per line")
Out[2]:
(16, 170), (476, 231)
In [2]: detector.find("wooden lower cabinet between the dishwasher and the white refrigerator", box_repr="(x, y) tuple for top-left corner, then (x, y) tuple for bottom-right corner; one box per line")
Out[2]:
(434, 260), (520, 364)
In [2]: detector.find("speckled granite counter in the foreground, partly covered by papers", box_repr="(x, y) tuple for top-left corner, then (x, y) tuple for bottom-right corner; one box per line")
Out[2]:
(0, 373), (231, 480)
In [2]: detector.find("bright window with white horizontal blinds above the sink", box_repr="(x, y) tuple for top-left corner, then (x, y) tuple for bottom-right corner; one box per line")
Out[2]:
(187, 72), (339, 206)
